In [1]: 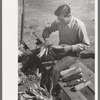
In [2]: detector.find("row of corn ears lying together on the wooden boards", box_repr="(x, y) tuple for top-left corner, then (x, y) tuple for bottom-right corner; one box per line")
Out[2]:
(59, 67), (91, 91)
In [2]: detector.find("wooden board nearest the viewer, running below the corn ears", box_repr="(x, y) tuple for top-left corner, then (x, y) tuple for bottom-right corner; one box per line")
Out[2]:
(58, 82), (88, 100)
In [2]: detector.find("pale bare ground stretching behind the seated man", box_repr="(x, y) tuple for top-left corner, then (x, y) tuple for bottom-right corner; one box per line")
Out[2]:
(18, 0), (95, 99)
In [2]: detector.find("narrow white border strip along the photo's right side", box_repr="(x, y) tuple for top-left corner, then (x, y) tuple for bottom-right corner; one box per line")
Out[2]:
(95, 0), (98, 100)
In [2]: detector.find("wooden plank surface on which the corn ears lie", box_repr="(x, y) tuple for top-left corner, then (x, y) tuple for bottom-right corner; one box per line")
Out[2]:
(58, 62), (95, 100)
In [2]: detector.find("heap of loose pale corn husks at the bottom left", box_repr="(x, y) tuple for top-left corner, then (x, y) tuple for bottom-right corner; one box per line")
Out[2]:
(18, 69), (56, 100)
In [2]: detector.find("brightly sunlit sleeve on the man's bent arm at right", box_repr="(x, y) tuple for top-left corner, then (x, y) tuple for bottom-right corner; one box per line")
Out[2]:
(72, 24), (90, 52)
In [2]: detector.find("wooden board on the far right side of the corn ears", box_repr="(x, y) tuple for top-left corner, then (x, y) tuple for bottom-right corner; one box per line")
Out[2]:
(71, 62), (95, 92)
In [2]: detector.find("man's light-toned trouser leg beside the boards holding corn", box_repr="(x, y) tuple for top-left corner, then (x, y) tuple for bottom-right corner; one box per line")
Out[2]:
(52, 56), (78, 88)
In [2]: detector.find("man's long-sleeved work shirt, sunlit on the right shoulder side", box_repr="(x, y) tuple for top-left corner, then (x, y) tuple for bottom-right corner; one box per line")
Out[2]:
(42, 16), (90, 52)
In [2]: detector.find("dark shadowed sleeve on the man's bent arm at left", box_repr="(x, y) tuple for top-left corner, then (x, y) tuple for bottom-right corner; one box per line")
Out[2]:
(42, 20), (58, 39)
